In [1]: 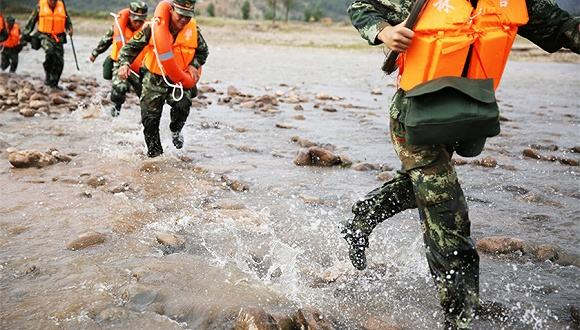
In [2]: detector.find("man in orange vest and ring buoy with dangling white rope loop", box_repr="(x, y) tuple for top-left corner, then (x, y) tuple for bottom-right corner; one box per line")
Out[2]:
(118, 0), (209, 157)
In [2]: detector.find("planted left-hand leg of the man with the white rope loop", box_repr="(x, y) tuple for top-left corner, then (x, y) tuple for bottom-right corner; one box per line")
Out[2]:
(140, 72), (167, 157)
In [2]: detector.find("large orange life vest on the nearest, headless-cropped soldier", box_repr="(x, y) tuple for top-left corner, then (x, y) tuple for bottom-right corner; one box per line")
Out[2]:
(398, 0), (528, 91)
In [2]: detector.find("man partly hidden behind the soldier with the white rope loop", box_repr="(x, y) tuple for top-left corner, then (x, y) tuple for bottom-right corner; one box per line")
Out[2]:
(89, 1), (147, 117)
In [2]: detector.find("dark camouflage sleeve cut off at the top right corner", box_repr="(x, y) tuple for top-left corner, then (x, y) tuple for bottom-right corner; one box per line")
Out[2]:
(518, 0), (580, 54)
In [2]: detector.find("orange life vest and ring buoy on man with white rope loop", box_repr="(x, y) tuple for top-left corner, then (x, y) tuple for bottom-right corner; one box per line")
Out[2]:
(143, 1), (197, 88)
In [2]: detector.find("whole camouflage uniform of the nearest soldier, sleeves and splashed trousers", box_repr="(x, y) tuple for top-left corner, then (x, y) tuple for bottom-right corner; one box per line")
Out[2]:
(343, 0), (580, 329)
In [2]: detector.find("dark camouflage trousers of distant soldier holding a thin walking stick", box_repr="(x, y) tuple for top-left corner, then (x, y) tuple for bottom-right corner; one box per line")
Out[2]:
(39, 33), (66, 87)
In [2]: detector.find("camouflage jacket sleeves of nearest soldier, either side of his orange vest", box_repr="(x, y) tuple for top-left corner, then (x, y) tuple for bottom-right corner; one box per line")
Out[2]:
(348, 0), (580, 53)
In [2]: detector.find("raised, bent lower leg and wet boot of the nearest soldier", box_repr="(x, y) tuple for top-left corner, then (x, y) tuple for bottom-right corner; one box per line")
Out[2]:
(341, 171), (417, 270)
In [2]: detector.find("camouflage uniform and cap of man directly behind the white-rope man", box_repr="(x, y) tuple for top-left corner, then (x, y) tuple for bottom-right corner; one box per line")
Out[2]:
(91, 1), (147, 116)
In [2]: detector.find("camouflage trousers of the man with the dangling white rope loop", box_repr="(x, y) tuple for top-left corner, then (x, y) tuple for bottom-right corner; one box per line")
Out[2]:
(140, 70), (197, 157)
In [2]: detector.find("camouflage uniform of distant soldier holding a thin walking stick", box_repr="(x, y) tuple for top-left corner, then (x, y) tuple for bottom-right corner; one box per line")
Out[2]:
(22, 6), (72, 87)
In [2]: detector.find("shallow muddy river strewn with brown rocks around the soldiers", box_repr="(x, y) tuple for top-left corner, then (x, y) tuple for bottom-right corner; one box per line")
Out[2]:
(0, 29), (580, 329)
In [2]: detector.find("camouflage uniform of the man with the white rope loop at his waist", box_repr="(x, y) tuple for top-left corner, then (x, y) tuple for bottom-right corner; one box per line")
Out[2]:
(119, 19), (209, 157)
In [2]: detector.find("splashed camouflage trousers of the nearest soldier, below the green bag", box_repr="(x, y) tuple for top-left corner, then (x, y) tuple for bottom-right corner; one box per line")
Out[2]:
(350, 92), (479, 329)
